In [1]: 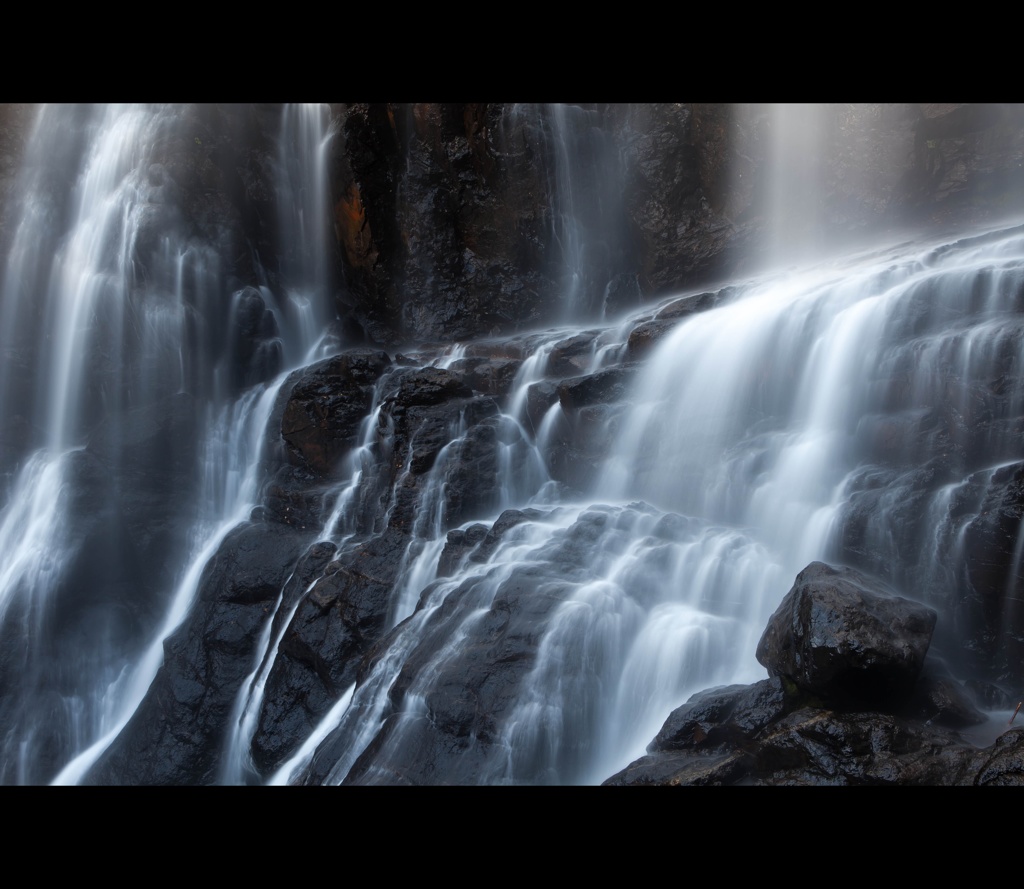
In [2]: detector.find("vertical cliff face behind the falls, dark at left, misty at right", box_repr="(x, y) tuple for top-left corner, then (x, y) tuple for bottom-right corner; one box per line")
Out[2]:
(332, 103), (1024, 343)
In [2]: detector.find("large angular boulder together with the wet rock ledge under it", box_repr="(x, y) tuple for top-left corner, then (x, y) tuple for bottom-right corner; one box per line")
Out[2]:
(604, 562), (1024, 786)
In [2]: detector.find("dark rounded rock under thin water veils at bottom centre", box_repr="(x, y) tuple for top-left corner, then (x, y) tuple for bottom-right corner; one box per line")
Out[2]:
(306, 508), (634, 785)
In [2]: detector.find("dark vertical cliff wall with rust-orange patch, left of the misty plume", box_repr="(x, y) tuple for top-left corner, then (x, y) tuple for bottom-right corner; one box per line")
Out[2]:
(332, 103), (764, 344)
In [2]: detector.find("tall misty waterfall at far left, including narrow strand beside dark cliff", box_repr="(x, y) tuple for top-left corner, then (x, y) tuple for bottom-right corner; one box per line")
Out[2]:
(0, 105), (339, 784)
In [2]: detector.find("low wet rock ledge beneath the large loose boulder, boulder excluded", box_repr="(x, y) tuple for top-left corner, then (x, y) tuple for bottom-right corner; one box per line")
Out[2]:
(604, 677), (1021, 787)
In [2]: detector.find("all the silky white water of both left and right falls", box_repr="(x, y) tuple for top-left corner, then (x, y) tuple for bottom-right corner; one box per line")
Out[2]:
(0, 105), (1024, 785)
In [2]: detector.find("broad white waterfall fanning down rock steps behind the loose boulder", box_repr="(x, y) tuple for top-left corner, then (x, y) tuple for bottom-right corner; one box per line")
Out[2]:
(290, 227), (1024, 784)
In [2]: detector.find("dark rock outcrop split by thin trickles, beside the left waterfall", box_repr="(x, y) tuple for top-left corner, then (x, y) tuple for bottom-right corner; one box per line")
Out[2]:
(81, 349), (544, 784)
